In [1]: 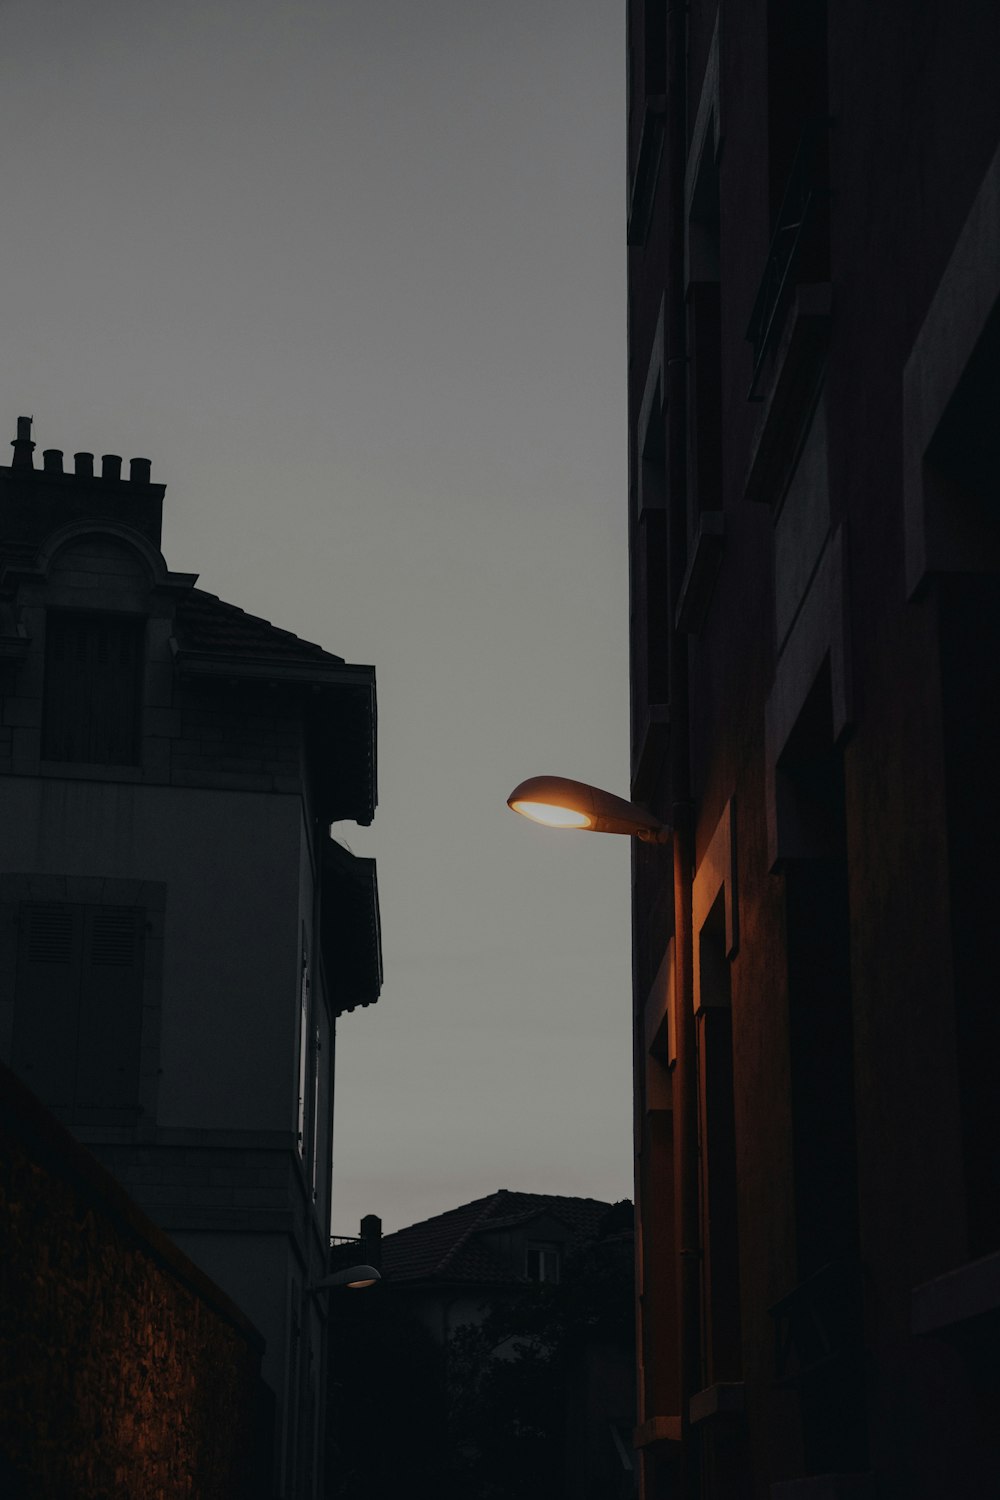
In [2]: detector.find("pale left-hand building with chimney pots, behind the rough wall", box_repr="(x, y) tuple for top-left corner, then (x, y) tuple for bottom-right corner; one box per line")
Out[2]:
(0, 419), (381, 1500)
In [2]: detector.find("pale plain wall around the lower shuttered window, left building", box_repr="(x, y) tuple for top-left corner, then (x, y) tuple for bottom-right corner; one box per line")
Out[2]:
(0, 777), (301, 1133)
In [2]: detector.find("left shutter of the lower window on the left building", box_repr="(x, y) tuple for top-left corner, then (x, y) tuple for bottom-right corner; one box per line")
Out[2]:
(12, 902), (84, 1118)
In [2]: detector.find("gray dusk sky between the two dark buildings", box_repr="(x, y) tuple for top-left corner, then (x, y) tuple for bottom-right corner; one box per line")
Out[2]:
(0, 0), (631, 1233)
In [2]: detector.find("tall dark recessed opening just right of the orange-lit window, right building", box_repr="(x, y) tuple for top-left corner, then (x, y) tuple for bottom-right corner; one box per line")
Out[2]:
(778, 662), (868, 1473)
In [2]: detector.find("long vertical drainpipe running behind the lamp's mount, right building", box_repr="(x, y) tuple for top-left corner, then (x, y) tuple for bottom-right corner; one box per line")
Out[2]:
(664, 0), (700, 1500)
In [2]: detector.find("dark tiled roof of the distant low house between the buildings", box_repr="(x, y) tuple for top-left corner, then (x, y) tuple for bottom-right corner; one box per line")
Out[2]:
(382, 1188), (612, 1283)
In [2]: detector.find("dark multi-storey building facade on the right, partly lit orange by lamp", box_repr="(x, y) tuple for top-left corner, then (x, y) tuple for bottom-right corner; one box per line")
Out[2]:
(627, 0), (1000, 1500)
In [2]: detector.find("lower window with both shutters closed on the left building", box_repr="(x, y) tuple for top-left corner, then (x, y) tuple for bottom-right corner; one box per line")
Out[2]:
(12, 902), (145, 1124)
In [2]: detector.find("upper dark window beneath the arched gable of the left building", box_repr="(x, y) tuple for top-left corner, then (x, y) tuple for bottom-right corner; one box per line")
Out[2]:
(42, 609), (145, 765)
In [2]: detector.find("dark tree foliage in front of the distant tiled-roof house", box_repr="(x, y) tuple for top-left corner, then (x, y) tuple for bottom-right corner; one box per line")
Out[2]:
(327, 1203), (634, 1500)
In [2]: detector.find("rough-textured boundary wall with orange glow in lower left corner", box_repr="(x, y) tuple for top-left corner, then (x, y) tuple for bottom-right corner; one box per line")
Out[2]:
(0, 1070), (265, 1500)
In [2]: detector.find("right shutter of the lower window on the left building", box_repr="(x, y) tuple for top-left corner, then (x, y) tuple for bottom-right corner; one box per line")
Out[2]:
(76, 906), (145, 1124)
